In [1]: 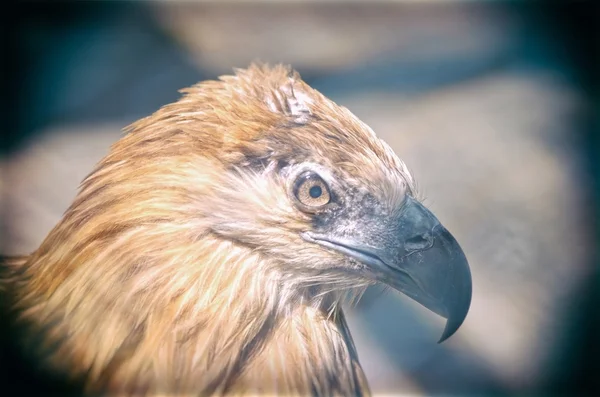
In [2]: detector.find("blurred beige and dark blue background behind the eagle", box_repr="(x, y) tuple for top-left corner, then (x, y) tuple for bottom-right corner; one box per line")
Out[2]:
(0, 0), (600, 396)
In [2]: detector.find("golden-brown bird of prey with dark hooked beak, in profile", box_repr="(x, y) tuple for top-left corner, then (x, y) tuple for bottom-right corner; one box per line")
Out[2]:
(0, 64), (471, 396)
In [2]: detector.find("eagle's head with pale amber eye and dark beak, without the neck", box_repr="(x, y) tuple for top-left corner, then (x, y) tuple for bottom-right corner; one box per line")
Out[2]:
(178, 65), (471, 341)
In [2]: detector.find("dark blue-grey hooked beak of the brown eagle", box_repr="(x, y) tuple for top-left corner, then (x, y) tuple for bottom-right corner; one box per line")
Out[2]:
(303, 197), (472, 343)
